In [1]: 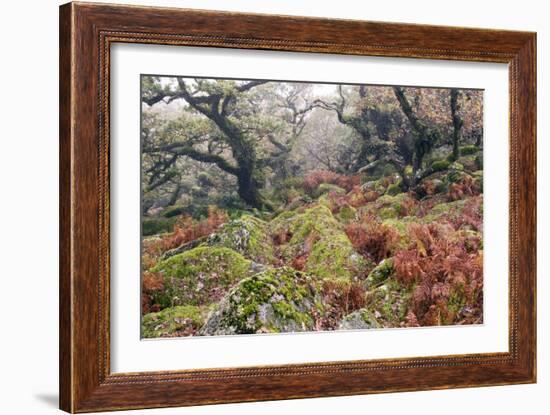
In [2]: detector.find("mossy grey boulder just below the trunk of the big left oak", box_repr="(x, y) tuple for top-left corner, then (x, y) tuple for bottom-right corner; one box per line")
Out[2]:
(206, 215), (275, 264)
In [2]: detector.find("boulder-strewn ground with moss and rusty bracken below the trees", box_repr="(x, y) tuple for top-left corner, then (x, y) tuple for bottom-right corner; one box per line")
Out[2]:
(142, 149), (483, 338)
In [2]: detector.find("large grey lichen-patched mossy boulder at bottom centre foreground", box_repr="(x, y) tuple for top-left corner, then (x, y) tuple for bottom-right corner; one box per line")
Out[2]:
(199, 267), (321, 336)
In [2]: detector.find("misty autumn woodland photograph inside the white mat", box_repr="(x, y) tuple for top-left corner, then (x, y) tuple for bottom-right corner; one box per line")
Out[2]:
(140, 75), (483, 339)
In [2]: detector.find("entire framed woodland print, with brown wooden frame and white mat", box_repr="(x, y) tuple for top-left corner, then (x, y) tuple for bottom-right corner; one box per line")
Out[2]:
(60, 3), (536, 412)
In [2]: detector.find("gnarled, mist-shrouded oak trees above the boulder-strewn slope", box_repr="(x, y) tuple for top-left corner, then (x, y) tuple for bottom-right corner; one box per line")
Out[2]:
(141, 76), (483, 216)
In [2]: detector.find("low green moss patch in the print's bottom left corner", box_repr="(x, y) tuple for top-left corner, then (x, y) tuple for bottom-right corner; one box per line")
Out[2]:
(141, 306), (204, 338)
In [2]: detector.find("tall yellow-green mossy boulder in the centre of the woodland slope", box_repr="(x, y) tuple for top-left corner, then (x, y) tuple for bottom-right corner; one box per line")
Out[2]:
(272, 204), (368, 278)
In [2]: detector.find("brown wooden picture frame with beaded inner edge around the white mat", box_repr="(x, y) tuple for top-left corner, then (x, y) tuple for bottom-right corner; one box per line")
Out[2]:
(60, 3), (536, 412)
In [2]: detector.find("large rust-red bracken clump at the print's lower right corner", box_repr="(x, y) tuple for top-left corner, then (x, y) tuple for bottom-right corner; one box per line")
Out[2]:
(394, 223), (483, 325)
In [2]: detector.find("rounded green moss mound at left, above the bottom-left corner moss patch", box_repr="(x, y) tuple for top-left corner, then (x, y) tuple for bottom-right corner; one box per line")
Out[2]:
(151, 246), (254, 307)
